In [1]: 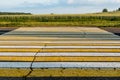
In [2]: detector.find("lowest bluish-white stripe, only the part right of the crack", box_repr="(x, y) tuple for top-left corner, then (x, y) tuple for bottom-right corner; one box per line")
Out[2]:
(32, 62), (120, 68)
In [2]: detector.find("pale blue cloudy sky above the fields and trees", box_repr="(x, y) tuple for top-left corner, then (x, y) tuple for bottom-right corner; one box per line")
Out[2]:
(0, 0), (120, 14)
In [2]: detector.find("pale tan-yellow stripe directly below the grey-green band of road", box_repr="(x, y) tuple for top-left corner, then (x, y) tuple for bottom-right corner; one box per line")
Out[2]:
(0, 35), (112, 41)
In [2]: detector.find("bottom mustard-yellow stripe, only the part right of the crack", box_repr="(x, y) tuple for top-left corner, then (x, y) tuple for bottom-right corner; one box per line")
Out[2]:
(29, 68), (120, 77)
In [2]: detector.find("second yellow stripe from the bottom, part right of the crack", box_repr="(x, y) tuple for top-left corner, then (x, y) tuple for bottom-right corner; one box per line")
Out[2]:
(35, 56), (120, 62)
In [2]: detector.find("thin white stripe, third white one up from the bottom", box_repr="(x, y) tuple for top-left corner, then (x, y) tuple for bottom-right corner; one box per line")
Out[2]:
(0, 46), (120, 49)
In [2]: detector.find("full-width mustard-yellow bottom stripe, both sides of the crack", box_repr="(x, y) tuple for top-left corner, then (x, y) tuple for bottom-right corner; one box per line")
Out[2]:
(0, 68), (120, 77)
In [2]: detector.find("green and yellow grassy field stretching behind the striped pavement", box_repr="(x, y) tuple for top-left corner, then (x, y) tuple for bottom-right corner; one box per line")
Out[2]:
(0, 11), (120, 27)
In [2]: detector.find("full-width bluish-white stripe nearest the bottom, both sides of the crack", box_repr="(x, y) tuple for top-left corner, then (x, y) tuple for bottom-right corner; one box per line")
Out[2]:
(0, 62), (120, 69)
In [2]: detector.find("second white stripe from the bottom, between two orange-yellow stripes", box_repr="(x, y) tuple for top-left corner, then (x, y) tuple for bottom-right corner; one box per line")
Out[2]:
(0, 52), (120, 57)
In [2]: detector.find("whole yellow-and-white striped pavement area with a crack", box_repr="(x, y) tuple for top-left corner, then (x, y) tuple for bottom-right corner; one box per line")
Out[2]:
(0, 27), (120, 80)
